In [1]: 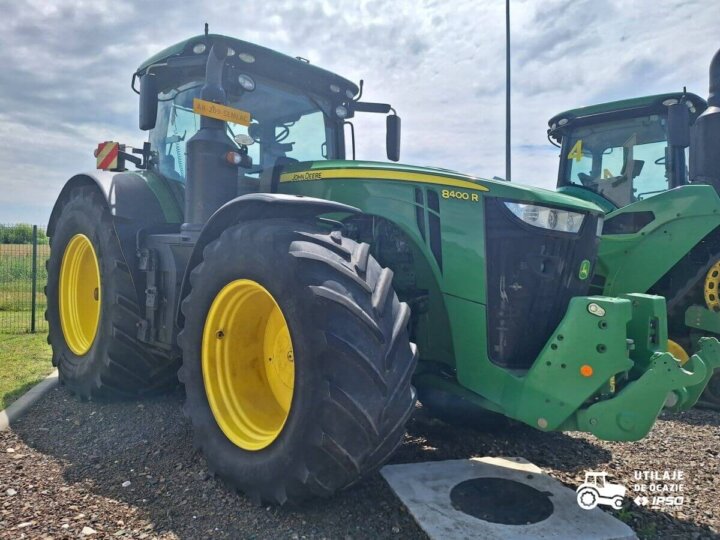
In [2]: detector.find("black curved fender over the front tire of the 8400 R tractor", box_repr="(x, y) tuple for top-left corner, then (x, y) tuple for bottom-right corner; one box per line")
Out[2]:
(175, 193), (360, 328)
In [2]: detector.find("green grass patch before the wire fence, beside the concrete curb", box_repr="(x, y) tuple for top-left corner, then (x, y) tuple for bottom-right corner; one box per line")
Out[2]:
(0, 333), (53, 410)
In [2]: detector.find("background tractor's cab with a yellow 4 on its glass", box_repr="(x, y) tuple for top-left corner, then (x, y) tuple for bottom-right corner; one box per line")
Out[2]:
(548, 92), (707, 212)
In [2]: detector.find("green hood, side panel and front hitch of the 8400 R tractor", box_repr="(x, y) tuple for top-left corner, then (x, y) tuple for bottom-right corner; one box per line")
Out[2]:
(272, 161), (720, 440)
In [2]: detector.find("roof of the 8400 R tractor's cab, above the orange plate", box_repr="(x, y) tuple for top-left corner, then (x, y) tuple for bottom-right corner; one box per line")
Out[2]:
(135, 34), (359, 98)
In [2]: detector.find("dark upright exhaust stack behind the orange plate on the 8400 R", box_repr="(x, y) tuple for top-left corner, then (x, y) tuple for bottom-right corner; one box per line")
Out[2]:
(182, 44), (238, 234)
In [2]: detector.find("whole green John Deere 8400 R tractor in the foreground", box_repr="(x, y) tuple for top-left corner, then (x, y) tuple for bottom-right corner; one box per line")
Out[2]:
(47, 34), (720, 503)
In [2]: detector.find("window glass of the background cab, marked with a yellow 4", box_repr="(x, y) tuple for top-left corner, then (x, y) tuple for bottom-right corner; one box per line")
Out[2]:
(561, 115), (669, 207)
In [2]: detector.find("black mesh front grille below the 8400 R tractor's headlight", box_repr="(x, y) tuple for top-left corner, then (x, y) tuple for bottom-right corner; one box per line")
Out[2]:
(485, 197), (599, 369)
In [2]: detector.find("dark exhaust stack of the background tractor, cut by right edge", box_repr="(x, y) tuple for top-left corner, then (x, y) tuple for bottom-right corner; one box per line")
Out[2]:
(690, 50), (720, 193)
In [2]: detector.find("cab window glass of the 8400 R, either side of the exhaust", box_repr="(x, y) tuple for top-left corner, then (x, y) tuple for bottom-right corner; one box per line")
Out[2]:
(150, 77), (342, 182)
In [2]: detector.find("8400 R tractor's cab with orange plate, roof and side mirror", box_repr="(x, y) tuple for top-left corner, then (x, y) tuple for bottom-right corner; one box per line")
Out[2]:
(133, 34), (399, 191)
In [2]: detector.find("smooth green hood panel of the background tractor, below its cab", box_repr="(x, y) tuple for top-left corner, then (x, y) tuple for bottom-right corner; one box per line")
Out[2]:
(592, 185), (720, 296)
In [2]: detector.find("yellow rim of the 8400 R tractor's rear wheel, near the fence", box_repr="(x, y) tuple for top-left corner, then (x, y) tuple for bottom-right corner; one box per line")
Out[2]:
(59, 234), (101, 356)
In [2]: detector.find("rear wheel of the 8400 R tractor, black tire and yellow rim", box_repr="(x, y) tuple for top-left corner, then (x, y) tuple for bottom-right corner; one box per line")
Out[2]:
(45, 186), (179, 399)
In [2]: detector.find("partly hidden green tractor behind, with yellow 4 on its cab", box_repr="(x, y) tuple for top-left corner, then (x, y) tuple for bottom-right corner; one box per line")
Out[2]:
(548, 51), (720, 408)
